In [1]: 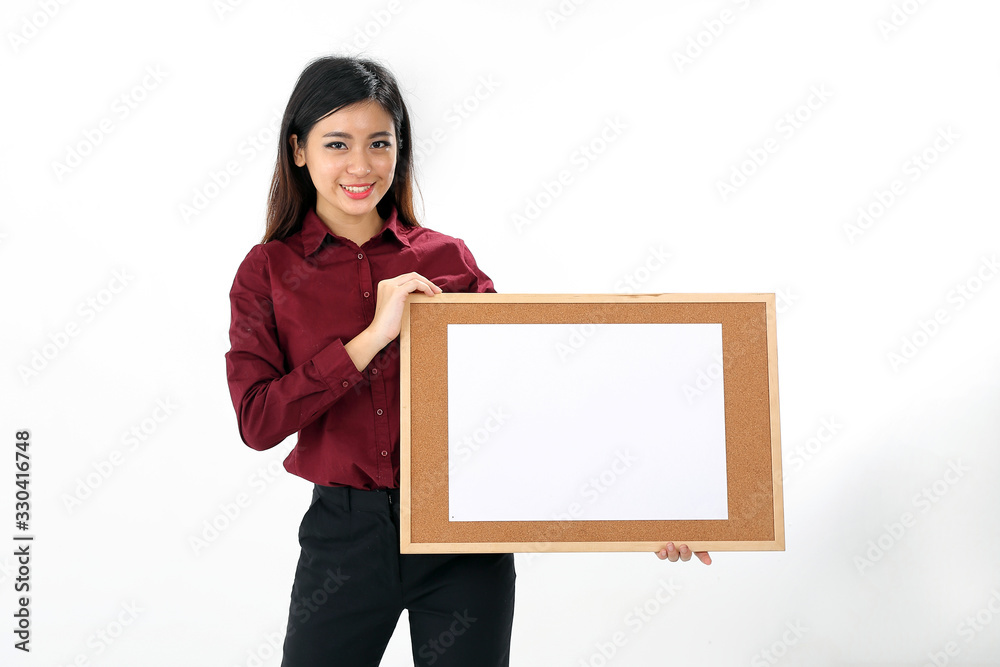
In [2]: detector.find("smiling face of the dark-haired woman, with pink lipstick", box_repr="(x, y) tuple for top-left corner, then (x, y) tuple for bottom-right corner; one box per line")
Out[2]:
(292, 102), (396, 234)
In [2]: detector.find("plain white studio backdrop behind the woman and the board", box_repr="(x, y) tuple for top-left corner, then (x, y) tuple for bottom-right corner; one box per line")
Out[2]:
(0, 0), (1000, 667)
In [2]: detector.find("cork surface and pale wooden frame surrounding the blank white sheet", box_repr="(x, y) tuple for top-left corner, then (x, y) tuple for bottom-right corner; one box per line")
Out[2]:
(400, 294), (784, 553)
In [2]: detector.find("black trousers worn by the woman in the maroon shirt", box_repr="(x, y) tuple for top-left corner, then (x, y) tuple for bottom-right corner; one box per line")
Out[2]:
(281, 485), (515, 667)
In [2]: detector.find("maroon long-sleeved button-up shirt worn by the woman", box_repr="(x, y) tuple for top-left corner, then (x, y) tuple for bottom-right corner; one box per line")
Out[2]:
(226, 210), (495, 489)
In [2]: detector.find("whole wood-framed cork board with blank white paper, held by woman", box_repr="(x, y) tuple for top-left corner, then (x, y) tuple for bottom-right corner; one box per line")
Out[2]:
(400, 294), (784, 553)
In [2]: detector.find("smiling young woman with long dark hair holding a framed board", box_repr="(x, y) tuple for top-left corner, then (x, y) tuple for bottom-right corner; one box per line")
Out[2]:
(226, 57), (707, 667)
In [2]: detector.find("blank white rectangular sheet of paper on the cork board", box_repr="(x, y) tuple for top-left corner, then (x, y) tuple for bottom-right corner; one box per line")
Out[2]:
(447, 323), (728, 521)
